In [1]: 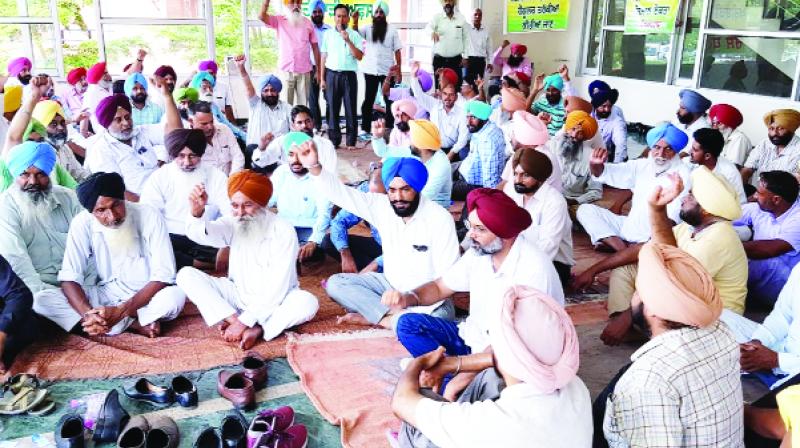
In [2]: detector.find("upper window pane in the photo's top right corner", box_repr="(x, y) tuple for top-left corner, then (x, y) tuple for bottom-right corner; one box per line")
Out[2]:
(709, 0), (800, 31)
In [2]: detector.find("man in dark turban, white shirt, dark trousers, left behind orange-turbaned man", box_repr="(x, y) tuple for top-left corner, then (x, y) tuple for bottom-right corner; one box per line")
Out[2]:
(140, 128), (231, 269)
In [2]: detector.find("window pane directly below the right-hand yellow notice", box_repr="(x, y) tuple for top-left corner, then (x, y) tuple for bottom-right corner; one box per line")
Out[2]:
(602, 31), (670, 82)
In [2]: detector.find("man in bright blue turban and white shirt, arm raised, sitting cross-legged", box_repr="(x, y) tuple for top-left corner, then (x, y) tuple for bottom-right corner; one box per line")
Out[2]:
(298, 142), (458, 327)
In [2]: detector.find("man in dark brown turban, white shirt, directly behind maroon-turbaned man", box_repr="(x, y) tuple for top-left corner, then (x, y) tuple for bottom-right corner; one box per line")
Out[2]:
(503, 147), (575, 287)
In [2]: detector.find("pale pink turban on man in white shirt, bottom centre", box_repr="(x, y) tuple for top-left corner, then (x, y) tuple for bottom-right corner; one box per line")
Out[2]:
(489, 286), (579, 394)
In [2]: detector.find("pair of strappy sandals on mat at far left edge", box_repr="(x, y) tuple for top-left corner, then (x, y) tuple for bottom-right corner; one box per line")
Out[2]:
(0, 373), (56, 416)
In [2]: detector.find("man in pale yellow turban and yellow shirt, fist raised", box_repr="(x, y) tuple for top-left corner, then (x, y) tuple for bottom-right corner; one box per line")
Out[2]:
(575, 166), (747, 345)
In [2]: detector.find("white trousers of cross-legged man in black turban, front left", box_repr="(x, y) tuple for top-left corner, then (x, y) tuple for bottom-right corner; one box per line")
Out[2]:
(33, 283), (186, 336)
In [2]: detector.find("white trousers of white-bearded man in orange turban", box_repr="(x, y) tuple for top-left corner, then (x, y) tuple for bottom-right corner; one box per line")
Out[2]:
(177, 267), (319, 341)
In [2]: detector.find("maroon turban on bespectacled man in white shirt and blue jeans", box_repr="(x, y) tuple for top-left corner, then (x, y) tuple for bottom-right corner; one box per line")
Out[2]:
(467, 188), (533, 239)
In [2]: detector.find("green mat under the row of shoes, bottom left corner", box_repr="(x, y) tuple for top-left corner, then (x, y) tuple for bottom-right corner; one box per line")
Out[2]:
(0, 358), (341, 448)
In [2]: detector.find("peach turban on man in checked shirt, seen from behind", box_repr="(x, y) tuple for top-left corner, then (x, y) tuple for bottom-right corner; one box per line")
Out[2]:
(636, 242), (722, 328)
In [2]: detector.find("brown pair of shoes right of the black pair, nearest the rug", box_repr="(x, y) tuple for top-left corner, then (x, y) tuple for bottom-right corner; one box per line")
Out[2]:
(217, 352), (267, 409)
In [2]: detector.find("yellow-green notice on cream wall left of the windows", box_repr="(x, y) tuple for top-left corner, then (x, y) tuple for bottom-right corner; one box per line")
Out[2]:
(505, 0), (569, 34)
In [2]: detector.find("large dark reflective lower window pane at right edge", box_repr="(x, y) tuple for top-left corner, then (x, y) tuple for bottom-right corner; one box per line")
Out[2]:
(700, 36), (800, 98)
